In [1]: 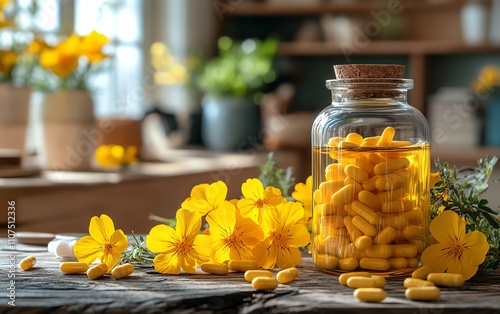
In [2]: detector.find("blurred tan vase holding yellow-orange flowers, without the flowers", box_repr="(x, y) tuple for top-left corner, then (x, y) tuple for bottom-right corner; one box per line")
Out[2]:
(40, 90), (100, 171)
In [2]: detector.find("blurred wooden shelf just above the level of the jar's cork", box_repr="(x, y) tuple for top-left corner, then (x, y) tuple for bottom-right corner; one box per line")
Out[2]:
(278, 40), (500, 56)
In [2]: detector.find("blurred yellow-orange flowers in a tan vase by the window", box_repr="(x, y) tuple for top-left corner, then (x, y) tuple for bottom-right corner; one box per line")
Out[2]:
(38, 31), (108, 171)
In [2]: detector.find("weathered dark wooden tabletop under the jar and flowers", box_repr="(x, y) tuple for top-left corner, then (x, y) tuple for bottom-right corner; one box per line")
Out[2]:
(0, 246), (500, 313)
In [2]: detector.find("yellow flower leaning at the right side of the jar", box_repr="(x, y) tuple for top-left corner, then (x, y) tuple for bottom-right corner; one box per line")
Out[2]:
(422, 210), (489, 280)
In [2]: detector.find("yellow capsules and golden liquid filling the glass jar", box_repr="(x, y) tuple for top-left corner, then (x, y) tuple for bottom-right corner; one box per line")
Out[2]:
(313, 126), (429, 275)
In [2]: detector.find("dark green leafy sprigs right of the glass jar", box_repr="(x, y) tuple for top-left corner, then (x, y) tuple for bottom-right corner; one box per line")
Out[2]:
(431, 157), (500, 270)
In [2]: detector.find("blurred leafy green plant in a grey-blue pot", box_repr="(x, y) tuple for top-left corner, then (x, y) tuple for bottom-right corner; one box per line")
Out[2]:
(198, 37), (278, 151)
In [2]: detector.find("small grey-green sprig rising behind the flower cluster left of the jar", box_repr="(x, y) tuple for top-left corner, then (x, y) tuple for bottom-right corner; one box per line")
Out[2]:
(259, 152), (295, 198)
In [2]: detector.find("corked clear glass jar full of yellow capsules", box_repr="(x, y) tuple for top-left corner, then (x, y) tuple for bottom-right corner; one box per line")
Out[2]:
(312, 65), (430, 276)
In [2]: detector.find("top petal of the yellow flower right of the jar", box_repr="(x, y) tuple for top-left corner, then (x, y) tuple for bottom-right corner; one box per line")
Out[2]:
(430, 210), (465, 243)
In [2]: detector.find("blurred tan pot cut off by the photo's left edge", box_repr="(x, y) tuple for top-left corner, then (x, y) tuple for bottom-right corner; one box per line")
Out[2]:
(0, 83), (31, 154)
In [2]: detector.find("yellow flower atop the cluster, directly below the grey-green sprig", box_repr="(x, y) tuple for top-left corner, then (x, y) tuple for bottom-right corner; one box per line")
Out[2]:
(238, 178), (284, 223)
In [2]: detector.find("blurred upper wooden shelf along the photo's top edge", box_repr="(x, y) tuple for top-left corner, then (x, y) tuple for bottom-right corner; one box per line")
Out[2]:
(227, 0), (474, 16)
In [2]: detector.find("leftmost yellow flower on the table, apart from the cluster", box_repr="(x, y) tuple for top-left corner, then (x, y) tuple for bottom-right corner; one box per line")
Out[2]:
(74, 214), (128, 271)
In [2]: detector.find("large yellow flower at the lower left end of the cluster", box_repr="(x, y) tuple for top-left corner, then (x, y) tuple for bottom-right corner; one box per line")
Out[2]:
(146, 209), (210, 274)
